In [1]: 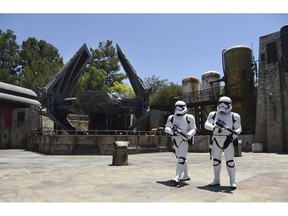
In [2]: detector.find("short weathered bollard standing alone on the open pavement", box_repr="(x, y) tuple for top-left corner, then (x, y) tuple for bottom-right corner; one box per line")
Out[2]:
(112, 141), (130, 166)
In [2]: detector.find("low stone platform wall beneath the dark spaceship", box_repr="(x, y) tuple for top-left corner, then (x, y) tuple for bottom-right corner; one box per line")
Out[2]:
(26, 134), (254, 155)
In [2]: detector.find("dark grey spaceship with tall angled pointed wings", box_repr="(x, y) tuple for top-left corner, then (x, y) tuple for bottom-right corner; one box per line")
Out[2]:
(39, 44), (151, 134)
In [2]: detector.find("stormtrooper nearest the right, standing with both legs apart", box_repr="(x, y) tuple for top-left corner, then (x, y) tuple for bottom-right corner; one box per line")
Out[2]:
(204, 96), (242, 189)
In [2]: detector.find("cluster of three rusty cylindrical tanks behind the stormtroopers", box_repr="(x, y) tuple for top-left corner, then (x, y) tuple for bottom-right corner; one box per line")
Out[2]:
(182, 45), (257, 135)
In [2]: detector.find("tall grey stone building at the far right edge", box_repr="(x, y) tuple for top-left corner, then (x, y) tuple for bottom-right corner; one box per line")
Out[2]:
(255, 25), (288, 152)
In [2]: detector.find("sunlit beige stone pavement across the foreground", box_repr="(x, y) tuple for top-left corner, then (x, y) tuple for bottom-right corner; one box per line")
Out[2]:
(0, 149), (288, 203)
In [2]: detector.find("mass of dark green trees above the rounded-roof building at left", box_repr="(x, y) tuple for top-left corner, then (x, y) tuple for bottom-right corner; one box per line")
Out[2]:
(0, 29), (63, 89)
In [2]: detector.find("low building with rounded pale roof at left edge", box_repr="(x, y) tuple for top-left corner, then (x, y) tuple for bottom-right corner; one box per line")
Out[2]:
(0, 82), (41, 149)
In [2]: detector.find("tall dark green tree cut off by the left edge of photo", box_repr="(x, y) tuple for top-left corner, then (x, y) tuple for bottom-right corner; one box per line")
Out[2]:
(0, 29), (20, 84)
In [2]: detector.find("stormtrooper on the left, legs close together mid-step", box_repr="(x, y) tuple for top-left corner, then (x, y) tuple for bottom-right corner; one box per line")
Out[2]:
(165, 101), (197, 185)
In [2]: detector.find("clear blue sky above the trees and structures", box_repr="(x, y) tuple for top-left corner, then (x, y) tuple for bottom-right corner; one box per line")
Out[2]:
(0, 1), (288, 84)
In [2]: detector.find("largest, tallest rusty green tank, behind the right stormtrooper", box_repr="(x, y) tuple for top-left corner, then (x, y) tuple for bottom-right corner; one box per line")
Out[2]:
(222, 45), (256, 133)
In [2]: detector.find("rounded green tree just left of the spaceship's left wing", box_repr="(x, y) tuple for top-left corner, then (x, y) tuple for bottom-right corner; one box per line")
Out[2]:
(19, 38), (63, 92)
